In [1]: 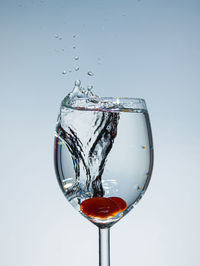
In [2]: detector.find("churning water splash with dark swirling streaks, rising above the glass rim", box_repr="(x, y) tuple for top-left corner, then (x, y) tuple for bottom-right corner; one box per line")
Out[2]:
(56, 80), (120, 200)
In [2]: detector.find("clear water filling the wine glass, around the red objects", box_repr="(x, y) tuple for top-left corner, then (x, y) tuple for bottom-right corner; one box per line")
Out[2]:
(55, 106), (153, 227)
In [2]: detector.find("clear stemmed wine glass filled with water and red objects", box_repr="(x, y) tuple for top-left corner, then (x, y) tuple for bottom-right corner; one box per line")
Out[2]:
(54, 92), (153, 266)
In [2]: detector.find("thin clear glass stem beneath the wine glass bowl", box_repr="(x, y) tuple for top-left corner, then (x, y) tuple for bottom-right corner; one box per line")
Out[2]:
(99, 228), (110, 266)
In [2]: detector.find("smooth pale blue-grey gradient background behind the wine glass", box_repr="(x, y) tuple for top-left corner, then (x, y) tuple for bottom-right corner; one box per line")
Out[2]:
(0, 0), (200, 266)
